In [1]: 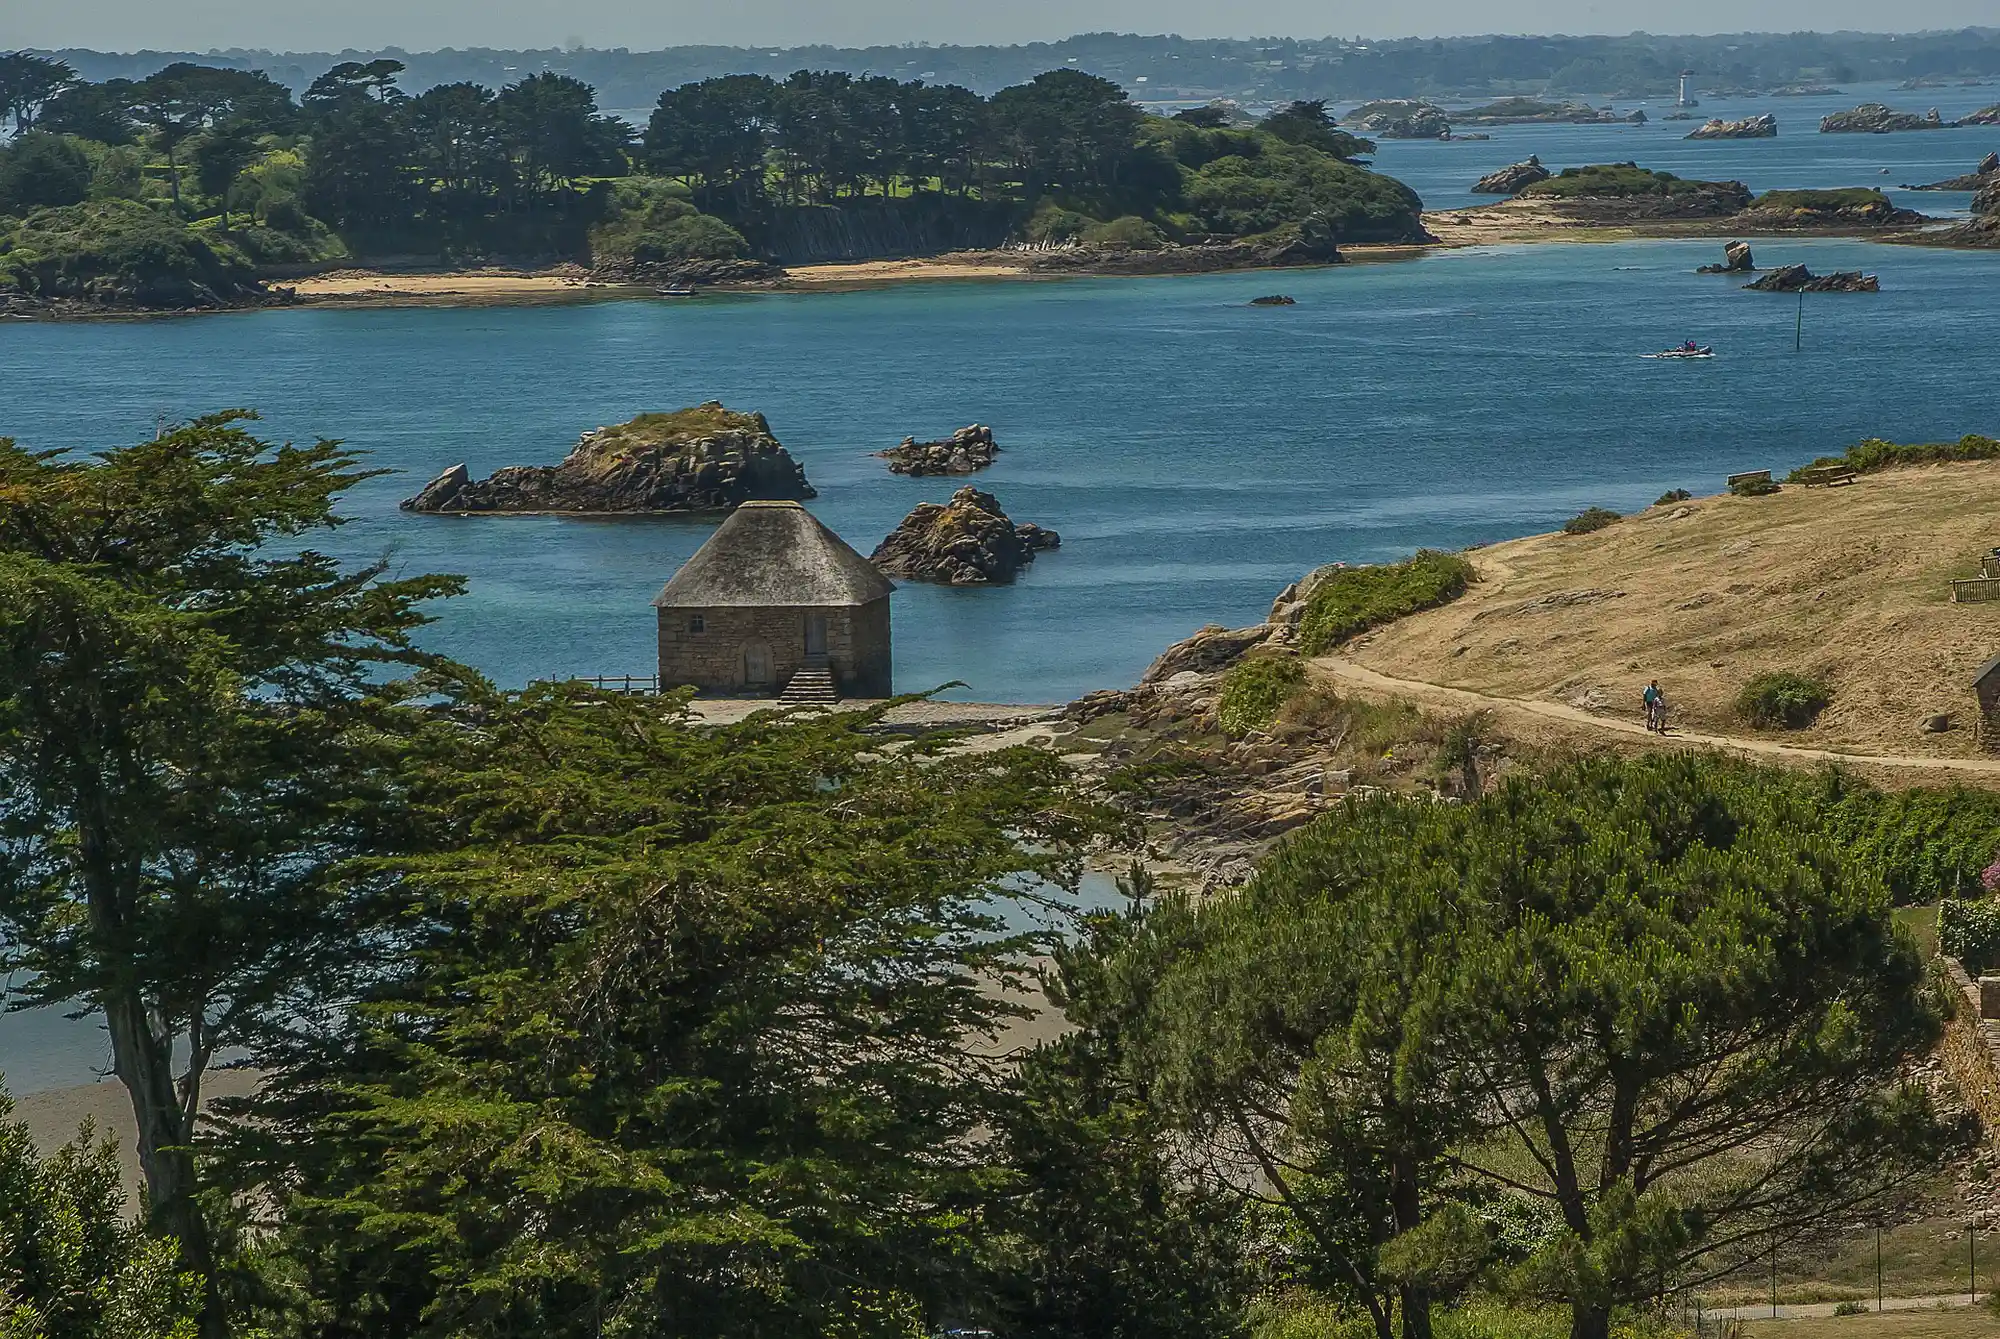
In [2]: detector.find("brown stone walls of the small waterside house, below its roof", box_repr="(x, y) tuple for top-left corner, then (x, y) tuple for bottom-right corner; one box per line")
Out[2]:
(660, 600), (890, 697)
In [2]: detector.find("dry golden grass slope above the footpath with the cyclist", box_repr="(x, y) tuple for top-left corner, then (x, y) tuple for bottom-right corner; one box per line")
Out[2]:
(1342, 462), (2000, 757)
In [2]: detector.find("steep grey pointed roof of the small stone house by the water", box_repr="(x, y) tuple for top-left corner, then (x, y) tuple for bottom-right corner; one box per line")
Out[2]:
(652, 502), (896, 610)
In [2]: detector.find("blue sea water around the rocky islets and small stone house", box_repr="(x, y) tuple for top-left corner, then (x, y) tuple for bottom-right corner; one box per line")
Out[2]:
(0, 75), (2000, 1093)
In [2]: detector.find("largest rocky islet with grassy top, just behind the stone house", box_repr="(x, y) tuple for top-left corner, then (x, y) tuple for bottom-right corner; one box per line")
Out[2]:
(402, 400), (816, 516)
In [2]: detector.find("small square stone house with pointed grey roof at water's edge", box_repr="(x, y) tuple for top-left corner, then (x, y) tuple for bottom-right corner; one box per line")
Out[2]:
(652, 502), (896, 701)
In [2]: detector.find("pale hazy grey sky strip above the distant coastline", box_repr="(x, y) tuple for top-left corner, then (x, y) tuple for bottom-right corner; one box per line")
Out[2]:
(11, 0), (2000, 50)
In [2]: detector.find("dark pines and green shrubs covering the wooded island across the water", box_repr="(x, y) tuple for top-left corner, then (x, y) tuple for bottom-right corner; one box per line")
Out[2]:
(0, 56), (1428, 312)
